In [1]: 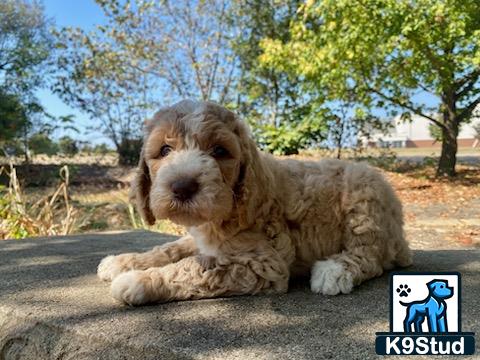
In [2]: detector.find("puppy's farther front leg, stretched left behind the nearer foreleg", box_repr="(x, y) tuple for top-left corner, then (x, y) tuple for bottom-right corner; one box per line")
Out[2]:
(97, 235), (197, 281)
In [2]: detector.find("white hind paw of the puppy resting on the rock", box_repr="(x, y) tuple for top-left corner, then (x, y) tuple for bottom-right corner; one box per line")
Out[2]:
(310, 259), (353, 295)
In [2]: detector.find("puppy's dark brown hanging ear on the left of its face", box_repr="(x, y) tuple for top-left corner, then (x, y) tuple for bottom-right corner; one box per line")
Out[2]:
(130, 121), (155, 225)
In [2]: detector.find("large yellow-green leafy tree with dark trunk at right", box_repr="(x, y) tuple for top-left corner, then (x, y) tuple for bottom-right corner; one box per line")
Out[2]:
(263, 0), (480, 176)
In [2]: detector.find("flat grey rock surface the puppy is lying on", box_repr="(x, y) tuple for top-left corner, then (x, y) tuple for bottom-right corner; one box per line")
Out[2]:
(0, 232), (480, 360)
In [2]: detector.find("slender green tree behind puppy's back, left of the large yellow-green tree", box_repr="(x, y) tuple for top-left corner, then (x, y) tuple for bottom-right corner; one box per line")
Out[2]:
(230, 0), (327, 154)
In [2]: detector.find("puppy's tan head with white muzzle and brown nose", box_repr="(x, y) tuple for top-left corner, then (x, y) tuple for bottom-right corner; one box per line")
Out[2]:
(133, 101), (248, 226)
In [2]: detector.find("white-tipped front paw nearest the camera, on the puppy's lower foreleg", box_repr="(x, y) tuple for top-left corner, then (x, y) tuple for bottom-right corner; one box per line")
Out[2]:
(110, 270), (147, 305)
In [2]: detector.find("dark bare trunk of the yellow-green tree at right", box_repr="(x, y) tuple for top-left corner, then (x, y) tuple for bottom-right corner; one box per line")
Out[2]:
(437, 118), (458, 176)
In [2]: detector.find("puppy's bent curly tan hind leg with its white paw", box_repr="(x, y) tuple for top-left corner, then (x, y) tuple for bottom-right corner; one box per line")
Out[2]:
(311, 167), (411, 295)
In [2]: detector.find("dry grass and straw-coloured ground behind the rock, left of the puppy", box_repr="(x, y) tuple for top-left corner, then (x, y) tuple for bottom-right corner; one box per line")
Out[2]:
(0, 164), (185, 239)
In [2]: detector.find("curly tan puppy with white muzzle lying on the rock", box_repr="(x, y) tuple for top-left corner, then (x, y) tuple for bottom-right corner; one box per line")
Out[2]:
(98, 100), (411, 305)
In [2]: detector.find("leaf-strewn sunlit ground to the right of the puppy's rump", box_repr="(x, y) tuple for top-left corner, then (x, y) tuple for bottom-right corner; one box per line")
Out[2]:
(385, 167), (480, 249)
